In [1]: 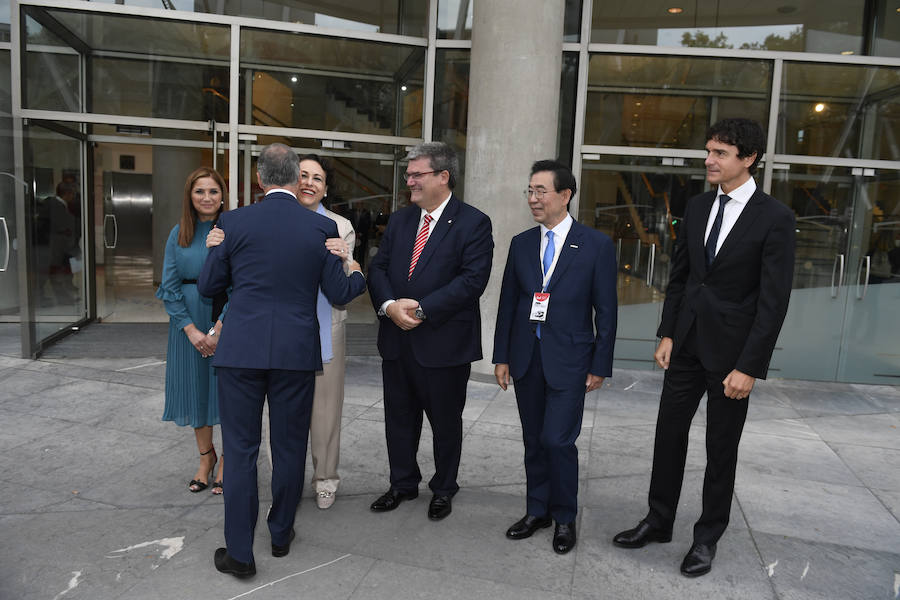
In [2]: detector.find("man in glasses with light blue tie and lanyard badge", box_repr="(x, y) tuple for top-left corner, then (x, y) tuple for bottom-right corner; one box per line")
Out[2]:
(493, 160), (617, 554)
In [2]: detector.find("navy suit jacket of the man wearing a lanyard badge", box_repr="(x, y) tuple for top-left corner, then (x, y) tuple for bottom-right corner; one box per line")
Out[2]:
(493, 221), (617, 388)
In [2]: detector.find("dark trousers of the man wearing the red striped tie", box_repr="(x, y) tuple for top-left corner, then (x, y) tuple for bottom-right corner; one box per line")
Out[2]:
(381, 336), (472, 496)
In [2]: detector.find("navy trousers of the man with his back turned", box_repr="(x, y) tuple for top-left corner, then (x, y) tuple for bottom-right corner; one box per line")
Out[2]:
(216, 367), (315, 563)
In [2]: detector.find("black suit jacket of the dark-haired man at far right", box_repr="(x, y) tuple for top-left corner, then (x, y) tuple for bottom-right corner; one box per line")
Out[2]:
(657, 188), (795, 379)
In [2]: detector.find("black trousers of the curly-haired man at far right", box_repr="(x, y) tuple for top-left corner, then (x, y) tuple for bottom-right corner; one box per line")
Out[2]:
(647, 330), (748, 544)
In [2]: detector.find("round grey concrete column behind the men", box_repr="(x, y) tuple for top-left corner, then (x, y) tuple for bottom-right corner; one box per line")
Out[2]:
(465, 0), (565, 374)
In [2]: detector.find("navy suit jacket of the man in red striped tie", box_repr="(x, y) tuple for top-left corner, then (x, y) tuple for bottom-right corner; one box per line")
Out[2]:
(366, 196), (494, 367)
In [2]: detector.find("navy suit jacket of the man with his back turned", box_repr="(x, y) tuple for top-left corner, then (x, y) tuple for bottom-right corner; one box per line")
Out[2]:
(197, 192), (366, 371)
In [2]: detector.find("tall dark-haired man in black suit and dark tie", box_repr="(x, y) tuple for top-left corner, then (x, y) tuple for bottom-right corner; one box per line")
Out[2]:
(613, 119), (794, 577)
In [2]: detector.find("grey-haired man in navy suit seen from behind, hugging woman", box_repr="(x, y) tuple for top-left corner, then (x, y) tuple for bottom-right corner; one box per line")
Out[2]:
(197, 144), (365, 578)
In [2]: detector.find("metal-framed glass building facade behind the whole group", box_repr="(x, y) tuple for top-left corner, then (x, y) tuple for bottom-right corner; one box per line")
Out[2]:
(7, 0), (900, 383)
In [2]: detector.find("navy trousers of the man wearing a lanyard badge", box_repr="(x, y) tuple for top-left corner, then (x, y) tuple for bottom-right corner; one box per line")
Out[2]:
(515, 341), (585, 523)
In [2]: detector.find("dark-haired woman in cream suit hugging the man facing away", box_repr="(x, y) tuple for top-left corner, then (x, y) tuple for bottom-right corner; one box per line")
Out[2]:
(206, 154), (356, 509)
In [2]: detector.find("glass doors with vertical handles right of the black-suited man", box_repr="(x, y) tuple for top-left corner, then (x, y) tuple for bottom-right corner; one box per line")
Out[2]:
(770, 165), (900, 385)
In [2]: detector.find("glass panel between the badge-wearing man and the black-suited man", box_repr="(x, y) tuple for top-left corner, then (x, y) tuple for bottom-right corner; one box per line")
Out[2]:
(577, 156), (706, 368)
